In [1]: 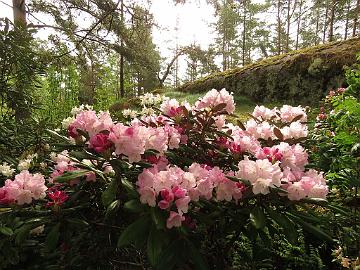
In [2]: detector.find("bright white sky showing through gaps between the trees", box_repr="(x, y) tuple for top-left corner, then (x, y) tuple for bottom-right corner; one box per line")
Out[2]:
(0, 0), (215, 81)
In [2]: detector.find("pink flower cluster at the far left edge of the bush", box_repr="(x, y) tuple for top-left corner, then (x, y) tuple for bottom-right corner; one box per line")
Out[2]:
(0, 171), (47, 205)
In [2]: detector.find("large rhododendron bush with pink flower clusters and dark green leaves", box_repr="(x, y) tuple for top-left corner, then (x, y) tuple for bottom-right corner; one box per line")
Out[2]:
(0, 89), (331, 269)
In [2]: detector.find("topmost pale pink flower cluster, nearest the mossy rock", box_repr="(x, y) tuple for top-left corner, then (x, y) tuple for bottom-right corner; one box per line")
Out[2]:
(195, 88), (235, 114)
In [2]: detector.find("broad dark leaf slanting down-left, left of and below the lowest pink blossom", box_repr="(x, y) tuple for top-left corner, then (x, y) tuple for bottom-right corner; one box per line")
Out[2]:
(117, 215), (150, 247)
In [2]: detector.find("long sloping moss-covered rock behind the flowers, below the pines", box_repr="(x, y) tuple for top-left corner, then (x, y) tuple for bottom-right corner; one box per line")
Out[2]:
(178, 38), (360, 104)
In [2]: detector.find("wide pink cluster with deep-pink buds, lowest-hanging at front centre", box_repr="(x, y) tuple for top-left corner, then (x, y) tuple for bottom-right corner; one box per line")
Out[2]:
(136, 163), (245, 229)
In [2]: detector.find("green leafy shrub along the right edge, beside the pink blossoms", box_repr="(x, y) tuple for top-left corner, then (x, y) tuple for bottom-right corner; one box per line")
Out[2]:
(309, 53), (360, 269)
